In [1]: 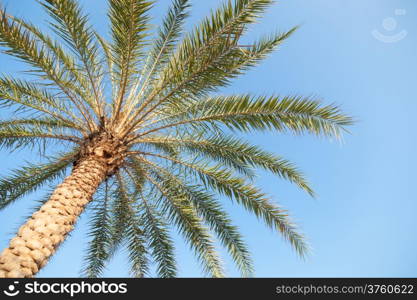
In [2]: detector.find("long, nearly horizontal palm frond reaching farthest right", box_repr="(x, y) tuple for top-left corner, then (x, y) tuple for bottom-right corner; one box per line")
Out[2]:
(138, 95), (353, 138)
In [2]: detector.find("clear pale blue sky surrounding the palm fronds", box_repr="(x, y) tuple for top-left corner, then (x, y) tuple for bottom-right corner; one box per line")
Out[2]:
(0, 0), (417, 277)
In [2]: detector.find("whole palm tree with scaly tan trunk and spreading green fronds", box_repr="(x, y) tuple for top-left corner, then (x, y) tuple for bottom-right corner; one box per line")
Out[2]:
(0, 0), (352, 277)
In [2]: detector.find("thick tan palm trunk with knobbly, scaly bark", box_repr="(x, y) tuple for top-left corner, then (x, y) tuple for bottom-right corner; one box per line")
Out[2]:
(0, 155), (108, 278)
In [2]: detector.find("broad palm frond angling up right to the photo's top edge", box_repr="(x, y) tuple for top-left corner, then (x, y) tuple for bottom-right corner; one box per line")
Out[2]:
(123, 0), (278, 127)
